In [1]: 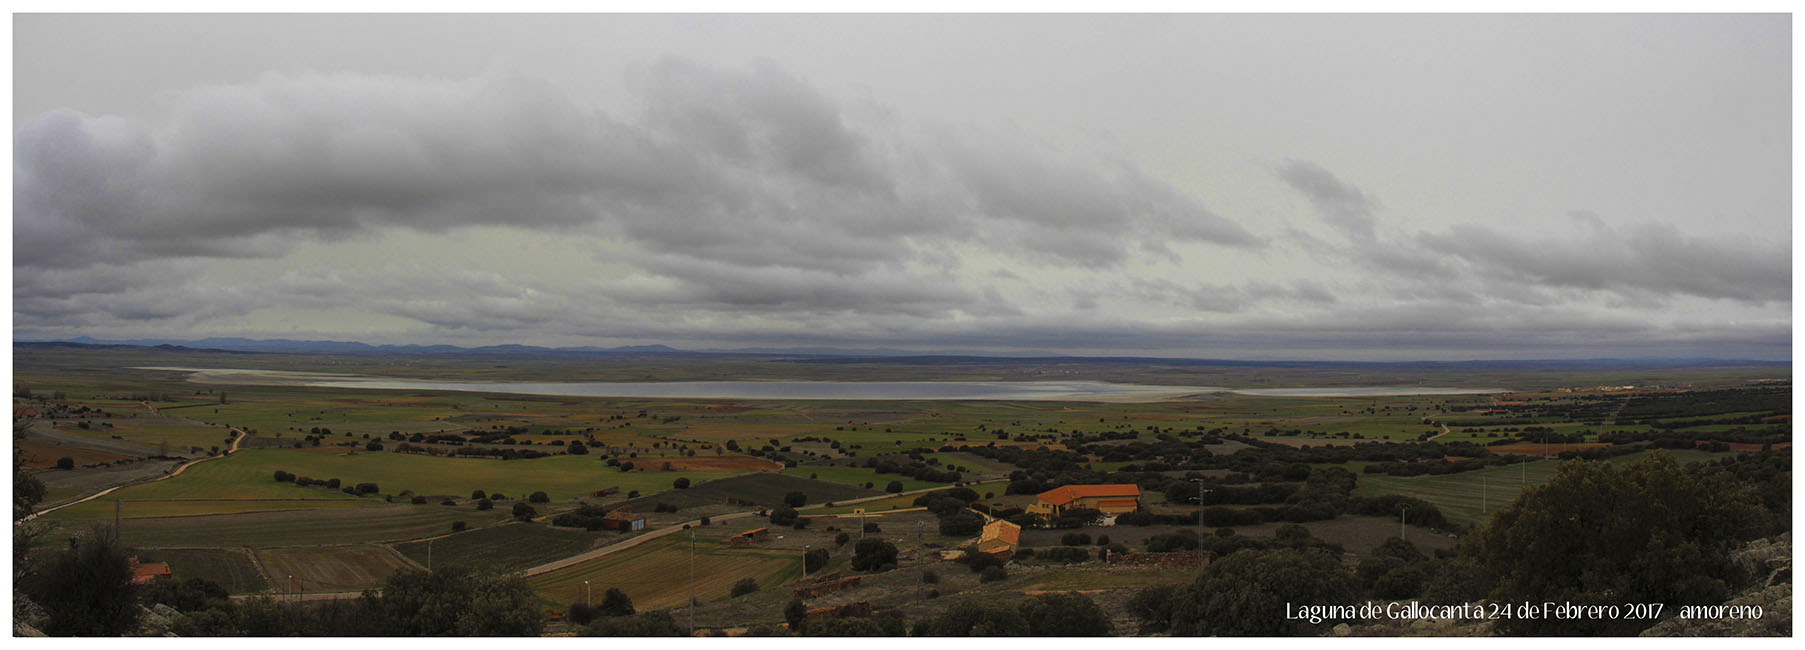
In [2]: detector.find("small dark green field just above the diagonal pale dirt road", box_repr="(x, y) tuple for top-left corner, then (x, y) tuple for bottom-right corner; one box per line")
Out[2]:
(395, 524), (619, 572)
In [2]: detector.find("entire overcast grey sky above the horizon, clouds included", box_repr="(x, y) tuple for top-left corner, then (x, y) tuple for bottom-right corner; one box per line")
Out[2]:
(13, 14), (1792, 361)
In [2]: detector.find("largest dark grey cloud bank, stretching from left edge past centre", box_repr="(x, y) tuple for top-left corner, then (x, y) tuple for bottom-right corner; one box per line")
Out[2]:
(14, 60), (1256, 281)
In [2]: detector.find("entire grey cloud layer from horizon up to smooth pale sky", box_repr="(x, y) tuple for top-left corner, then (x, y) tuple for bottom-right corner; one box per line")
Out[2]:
(13, 58), (1791, 358)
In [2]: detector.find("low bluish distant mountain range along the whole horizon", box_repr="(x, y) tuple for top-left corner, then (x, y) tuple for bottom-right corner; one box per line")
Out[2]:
(13, 336), (1792, 370)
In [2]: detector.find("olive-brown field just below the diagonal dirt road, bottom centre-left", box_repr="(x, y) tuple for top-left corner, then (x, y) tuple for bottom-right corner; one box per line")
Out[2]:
(527, 536), (801, 612)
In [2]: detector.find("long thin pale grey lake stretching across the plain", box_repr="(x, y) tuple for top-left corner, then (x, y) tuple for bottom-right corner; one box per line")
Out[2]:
(139, 367), (1504, 401)
